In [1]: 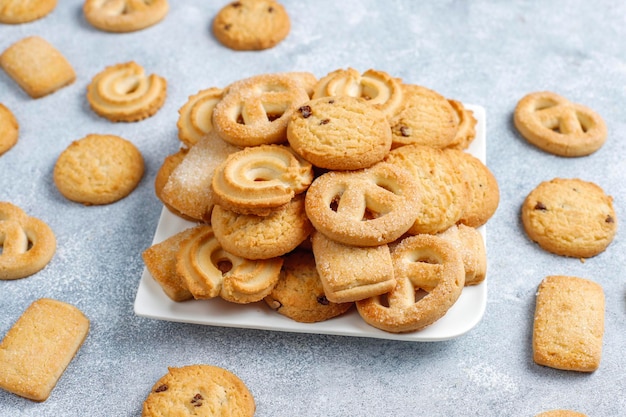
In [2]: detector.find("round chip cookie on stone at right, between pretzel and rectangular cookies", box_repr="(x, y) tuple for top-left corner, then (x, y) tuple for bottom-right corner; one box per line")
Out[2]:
(522, 178), (617, 258)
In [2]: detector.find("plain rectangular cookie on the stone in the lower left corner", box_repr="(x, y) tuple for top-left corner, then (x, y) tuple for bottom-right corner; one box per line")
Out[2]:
(0, 298), (89, 401)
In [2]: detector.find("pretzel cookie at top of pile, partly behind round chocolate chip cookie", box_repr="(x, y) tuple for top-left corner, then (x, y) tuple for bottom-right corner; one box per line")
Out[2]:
(213, 73), (312, 146)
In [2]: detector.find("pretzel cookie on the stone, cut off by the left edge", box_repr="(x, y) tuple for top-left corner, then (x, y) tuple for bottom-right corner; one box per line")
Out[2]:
(0, 202), (56, 280)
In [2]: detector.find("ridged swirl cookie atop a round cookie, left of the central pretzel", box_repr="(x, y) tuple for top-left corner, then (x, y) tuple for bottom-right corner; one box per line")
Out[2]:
(211, 145), (313, 216)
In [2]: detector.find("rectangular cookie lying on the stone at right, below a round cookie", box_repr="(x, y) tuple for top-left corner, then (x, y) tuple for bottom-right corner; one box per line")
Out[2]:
(533, 275), (604, 372)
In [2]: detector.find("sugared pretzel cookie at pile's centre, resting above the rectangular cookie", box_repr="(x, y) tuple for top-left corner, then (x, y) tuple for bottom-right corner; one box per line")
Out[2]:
(306, 163), (420, 246)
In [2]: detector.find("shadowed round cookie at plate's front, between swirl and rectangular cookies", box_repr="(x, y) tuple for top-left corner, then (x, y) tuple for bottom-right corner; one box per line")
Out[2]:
(265, 250), (353, 323)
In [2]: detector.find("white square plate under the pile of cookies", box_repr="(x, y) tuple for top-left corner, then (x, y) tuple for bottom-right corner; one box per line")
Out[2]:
(135, 105), (487, 342)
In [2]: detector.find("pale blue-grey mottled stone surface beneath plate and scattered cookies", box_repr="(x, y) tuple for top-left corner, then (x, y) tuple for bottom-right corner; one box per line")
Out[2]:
(0, 0), (626, 417)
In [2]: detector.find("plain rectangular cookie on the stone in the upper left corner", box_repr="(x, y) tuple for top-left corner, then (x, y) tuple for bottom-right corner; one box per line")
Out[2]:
(0, 36), (76, 98)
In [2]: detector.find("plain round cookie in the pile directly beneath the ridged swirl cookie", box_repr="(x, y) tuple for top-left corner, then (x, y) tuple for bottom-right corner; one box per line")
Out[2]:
(211, 195), (313, 259)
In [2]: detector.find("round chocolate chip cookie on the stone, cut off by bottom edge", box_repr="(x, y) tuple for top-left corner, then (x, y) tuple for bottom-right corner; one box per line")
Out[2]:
(141, 365), (256, 417)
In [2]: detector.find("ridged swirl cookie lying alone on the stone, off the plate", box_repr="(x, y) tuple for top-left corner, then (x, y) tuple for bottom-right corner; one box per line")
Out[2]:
(87, 61), (167, 122)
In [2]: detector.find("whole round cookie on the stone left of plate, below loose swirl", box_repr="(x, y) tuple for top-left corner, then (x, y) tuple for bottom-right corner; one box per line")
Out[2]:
(54, 134), (144, 205)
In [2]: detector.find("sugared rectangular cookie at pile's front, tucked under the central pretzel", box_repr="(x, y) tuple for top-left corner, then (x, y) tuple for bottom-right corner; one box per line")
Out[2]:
(312, 232), (396, 303)
